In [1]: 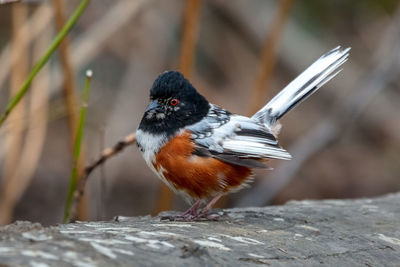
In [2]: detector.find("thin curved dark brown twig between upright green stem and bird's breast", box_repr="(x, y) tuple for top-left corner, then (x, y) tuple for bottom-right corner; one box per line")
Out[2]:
(70, 133), (136, 221)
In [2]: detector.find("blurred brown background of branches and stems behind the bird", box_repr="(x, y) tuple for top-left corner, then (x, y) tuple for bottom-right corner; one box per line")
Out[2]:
(0, 0), (400, 225)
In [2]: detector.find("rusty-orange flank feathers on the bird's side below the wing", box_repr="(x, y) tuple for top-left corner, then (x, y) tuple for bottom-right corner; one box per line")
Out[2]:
(154, 131), (252, 199)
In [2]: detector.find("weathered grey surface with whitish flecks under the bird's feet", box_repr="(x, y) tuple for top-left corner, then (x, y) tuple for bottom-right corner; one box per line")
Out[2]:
(0, 194), (400, 267)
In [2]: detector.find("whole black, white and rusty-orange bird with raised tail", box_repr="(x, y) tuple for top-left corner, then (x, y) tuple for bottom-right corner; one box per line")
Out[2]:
(136, 46), (350, 221)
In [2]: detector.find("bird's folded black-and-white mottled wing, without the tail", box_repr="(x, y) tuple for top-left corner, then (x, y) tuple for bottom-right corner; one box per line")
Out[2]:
(186, 104), (291, 168)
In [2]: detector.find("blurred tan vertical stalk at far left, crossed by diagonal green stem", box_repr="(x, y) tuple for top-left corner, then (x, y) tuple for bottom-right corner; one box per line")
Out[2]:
(0, 4), (29, 224)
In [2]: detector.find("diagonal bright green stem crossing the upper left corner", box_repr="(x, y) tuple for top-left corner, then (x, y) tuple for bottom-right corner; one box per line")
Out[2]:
(0, 0), (90, 127)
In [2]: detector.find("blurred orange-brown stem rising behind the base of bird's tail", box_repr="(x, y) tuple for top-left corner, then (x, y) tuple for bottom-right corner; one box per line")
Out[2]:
(250, 0), (295, 114)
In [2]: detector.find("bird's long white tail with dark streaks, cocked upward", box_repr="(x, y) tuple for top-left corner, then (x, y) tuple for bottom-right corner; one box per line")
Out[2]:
(253, 46), (350, 125)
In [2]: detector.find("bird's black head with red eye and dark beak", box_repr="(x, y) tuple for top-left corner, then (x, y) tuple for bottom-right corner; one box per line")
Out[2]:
(139, 71), (209, 135)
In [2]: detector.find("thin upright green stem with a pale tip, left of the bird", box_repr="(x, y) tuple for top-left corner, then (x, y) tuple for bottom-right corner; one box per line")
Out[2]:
(64, 70), (92, 223)
